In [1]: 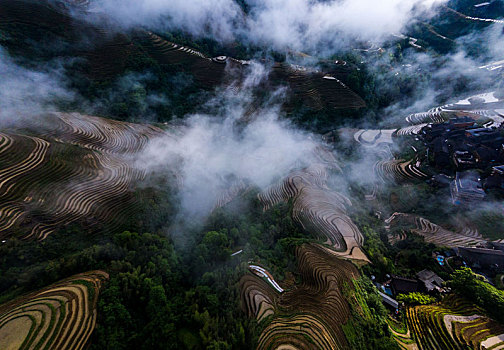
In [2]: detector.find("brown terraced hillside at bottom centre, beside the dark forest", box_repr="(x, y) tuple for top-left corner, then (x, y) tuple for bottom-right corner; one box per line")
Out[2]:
(241, 245), (358, 349)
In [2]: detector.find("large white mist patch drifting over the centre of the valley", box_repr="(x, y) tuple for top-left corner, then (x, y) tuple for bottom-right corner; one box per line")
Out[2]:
(137, 63), (319, 219)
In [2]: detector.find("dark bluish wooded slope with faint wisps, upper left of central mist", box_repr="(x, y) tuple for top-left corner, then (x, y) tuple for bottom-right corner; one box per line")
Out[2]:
(69, 45), (210, 123)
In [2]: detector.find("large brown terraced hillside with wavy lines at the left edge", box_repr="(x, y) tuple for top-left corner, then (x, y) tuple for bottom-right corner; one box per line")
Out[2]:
(0, 113), (162, 239)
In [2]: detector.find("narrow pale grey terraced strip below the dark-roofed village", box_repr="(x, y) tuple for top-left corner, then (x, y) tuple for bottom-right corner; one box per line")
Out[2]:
(385, 213), (486, 248)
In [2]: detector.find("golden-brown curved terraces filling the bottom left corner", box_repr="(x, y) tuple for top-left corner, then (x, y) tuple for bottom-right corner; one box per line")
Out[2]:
(0, 271), (108, 350)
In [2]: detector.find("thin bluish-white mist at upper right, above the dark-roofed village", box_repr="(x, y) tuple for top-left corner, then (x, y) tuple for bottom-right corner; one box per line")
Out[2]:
(362, 23), (504, 128)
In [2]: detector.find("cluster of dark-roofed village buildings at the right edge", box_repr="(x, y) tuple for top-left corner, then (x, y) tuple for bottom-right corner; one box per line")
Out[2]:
(419, 117), (504, 205)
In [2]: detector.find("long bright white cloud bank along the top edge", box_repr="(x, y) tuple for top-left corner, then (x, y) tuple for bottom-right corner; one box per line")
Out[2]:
(84, 0), (446, 53)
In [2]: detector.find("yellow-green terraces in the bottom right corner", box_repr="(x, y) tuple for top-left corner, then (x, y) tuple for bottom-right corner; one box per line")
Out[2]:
(406, 296), (504, 350)
